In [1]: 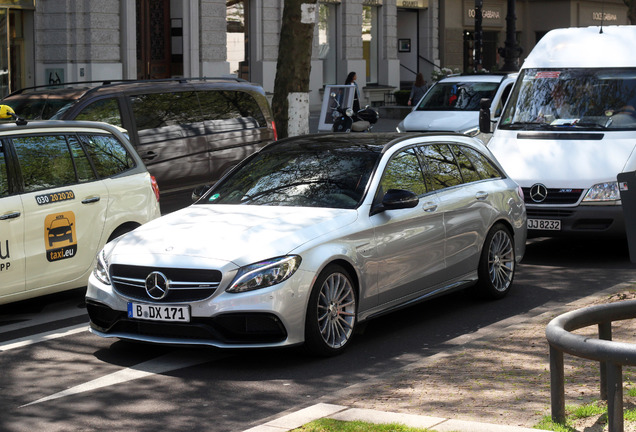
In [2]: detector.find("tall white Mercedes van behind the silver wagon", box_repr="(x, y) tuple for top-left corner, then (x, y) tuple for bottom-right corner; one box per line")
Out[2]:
(482, 26), (636, 237)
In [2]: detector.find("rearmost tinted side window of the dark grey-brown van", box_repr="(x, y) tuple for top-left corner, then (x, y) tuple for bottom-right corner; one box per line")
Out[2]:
(197, 90), (267, 128)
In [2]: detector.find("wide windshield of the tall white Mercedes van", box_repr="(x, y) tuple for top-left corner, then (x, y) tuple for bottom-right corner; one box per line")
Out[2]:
(498, 68), (636, 130)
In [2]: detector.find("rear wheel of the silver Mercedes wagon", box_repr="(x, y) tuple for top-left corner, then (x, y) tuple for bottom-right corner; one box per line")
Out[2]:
(477, 223), (516, 299)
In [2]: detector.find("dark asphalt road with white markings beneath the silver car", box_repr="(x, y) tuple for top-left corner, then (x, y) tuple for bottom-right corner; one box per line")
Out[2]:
(0, 239), (636, 432)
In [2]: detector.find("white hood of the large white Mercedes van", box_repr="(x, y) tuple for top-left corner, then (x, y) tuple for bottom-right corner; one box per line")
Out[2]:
(488, 130), (635, 189)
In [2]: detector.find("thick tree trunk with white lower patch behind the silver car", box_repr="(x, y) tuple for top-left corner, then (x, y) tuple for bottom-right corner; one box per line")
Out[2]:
(272, 0), (317, 138)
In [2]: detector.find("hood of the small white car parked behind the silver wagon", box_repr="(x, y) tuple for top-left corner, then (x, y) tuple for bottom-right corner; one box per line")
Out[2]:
(403, 111), (479, 133)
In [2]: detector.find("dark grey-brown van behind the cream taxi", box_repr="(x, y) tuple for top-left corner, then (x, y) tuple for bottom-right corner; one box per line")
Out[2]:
(2, 78), (276, 213)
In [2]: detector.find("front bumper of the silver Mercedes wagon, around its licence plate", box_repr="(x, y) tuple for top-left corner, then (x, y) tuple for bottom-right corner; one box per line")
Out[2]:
(86, 270), (313, 348)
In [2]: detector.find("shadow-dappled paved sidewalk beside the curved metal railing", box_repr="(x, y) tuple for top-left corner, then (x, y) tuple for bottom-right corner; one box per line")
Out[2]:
(245, 282), (636, 432)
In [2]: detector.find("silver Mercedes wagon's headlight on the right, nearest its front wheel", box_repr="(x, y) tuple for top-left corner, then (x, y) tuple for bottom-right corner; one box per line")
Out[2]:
(226, 255), (301, 293)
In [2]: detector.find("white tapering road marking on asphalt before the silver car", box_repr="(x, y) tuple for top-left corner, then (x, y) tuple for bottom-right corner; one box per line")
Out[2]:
(20, 350), (215, 408)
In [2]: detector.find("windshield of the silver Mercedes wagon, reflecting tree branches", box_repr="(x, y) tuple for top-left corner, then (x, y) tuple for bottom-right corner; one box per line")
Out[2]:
(204, 144), (380, 209)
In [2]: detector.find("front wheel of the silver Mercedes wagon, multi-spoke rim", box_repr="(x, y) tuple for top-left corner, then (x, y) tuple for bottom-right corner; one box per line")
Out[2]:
(305, 264), (357, 357)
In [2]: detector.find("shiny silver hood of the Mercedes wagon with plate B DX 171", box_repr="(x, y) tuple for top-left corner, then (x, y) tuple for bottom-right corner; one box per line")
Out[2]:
(112, 205), (358, 266)
